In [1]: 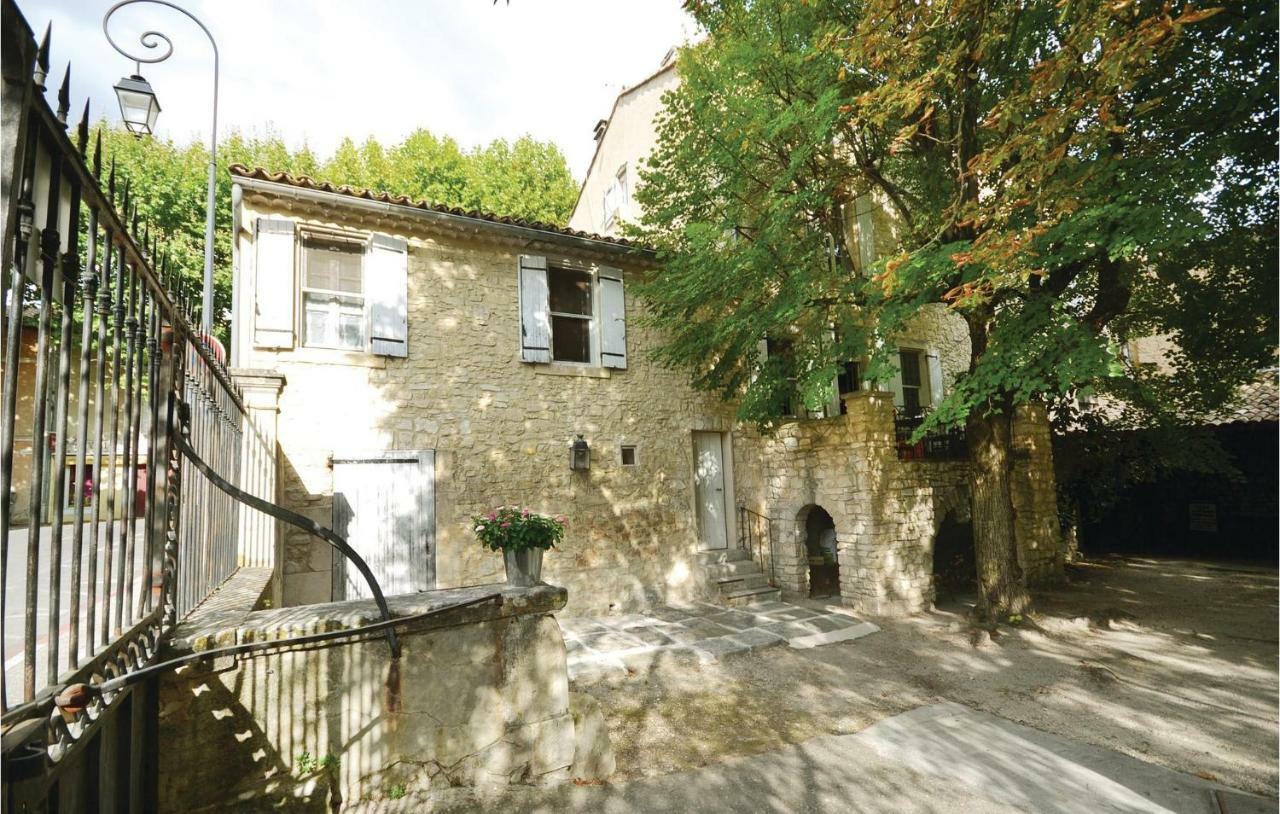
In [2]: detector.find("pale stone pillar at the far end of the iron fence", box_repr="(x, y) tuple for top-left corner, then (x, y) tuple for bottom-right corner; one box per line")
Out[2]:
(230, 369), (284, 607)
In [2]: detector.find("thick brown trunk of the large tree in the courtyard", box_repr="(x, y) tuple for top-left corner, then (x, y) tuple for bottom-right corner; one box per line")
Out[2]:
(966, 408), (1030, 621)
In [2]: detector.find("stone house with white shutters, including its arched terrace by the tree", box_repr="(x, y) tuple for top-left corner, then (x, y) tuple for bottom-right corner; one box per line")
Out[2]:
(230, 149), (1061, 613)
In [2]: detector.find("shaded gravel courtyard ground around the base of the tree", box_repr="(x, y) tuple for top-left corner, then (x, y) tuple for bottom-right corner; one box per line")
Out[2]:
(573, 558), (1280, 796)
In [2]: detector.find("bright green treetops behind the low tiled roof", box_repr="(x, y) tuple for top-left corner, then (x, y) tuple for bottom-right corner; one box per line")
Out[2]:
(96, 123), (577, 342)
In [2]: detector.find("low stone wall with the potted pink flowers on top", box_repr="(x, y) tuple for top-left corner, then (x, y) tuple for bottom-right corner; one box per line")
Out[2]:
(159, 585), (588, 811)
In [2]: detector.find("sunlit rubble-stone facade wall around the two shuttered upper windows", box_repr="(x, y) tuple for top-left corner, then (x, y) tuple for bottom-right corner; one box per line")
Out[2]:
(234, 193), (753, 613)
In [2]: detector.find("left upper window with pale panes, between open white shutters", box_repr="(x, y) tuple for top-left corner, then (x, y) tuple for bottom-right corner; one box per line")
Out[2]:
(302, 239), (366, 351)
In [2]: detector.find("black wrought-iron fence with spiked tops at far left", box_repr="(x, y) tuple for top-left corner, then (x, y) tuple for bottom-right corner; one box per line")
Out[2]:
(0, 0), (254, 810)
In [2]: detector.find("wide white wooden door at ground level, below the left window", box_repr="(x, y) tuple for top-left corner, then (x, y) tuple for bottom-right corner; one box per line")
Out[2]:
(333, 449), (435, 600)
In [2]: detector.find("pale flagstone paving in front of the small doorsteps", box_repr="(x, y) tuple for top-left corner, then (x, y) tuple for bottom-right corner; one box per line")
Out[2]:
(559, 602), (879, 681)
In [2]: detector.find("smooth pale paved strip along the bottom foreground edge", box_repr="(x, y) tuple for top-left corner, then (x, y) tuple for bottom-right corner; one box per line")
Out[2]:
(412, 703), (1276, 814)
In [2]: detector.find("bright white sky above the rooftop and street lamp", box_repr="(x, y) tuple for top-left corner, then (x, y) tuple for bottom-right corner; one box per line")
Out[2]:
(18, 0), (696, 180)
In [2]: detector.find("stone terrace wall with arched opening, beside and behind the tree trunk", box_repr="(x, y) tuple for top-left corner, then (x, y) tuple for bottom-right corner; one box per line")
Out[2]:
(762, 390), (1065, 616)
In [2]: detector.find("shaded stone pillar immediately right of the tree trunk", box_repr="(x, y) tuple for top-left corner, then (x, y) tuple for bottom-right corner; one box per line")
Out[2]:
(1010, 404), (1066, 585)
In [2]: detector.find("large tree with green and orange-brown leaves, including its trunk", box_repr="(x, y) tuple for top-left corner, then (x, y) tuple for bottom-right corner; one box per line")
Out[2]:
(637, 0), (1277, 616)
